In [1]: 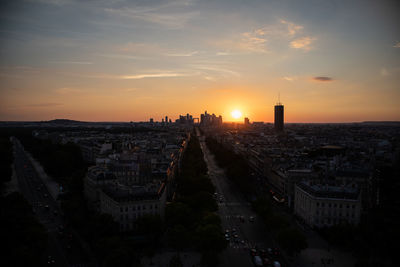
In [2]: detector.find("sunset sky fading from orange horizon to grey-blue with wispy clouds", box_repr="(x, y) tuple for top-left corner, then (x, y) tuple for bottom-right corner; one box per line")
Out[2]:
(0, 0), (400, 122)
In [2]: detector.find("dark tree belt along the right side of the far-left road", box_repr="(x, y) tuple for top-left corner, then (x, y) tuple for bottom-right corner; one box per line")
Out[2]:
(8, 129), (140, 266)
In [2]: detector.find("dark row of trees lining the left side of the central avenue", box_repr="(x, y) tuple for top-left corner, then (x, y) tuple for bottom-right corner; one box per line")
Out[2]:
(166, 136), (227, 265)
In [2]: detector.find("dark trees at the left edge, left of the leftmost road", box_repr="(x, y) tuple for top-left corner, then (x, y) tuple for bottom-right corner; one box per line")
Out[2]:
(0, 131), (47, 266)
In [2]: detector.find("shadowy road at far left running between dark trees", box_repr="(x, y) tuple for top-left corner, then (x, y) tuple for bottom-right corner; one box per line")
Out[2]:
(12, 138), (85, 267)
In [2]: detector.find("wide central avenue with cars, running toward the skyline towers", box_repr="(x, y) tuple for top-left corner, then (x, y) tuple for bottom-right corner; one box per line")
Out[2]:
(197, 132), (280, 267)
